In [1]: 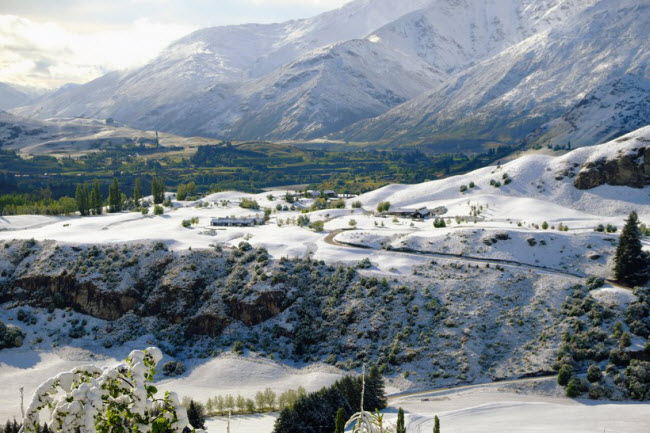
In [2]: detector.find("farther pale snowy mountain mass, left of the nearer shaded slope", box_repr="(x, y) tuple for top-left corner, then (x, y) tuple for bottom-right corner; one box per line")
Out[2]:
(17, 0), (608, 143)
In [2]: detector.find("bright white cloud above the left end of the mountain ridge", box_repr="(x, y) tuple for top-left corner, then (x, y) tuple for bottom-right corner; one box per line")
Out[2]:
(0, 15), (194, 88)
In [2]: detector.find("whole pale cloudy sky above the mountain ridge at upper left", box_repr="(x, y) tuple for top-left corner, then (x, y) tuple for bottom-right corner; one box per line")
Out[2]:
(0, 0), (349, 89)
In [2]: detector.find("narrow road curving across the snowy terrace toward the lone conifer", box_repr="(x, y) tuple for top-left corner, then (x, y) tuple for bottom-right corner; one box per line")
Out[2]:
(324, 229), (630, 290)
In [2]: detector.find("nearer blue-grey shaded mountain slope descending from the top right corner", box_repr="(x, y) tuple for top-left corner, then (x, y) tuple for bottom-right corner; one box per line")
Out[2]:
(340, 0), (650, 149)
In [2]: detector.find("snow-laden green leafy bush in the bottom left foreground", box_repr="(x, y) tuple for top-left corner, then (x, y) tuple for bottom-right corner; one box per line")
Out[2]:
(24, 347), (201, 433)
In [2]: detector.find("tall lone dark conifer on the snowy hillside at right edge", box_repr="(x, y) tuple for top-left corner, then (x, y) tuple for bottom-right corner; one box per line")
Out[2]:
(614, 212), (649, 286)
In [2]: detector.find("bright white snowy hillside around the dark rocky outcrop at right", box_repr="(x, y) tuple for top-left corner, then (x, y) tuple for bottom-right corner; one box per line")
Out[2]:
(352, 126), (650, 219)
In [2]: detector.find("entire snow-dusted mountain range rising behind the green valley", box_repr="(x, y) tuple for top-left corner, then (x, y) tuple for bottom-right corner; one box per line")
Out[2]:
(15, 0), (648, 150)
